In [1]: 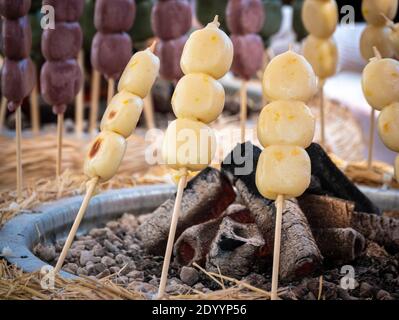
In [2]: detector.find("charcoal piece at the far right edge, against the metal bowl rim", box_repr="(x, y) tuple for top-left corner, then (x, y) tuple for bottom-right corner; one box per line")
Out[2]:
(352, 212), (399, 253)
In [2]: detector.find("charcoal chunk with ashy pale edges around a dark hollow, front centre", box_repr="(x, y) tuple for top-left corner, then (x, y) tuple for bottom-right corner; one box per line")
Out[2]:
(206, 217), (265, 278)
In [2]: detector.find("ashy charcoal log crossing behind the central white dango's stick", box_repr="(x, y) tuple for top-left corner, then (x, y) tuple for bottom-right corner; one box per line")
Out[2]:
(137, 168), (236, 254)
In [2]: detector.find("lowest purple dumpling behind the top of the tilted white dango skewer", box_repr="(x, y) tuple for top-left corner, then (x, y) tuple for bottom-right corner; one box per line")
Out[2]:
(91, 32), (133, 79)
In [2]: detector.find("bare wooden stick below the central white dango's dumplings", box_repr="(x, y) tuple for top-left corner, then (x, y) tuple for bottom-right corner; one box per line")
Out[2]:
(158, 172), (187, 299)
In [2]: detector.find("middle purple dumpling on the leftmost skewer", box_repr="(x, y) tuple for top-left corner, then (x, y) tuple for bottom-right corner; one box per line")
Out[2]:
(2, 16), (32, 60)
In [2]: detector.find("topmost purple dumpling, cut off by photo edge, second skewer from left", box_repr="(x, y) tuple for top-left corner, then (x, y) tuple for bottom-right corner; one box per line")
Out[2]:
(43, 0), (85, 22)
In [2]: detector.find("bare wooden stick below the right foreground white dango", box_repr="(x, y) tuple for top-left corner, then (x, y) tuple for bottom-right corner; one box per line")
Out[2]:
(271, 195), (284, 300)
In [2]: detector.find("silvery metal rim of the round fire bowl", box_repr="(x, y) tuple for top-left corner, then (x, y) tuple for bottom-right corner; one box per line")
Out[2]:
(0, 185), (399, 278)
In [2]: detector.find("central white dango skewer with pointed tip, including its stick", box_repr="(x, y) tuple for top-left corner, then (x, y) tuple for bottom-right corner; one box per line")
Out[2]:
(158, 16), (233, 299)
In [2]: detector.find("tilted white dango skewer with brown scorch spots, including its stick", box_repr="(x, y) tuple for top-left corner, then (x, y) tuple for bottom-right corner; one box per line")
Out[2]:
(54, 44), (160, 274)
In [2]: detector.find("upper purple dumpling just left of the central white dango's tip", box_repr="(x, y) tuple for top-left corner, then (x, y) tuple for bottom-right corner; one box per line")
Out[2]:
(151, 0), (192, 40)
